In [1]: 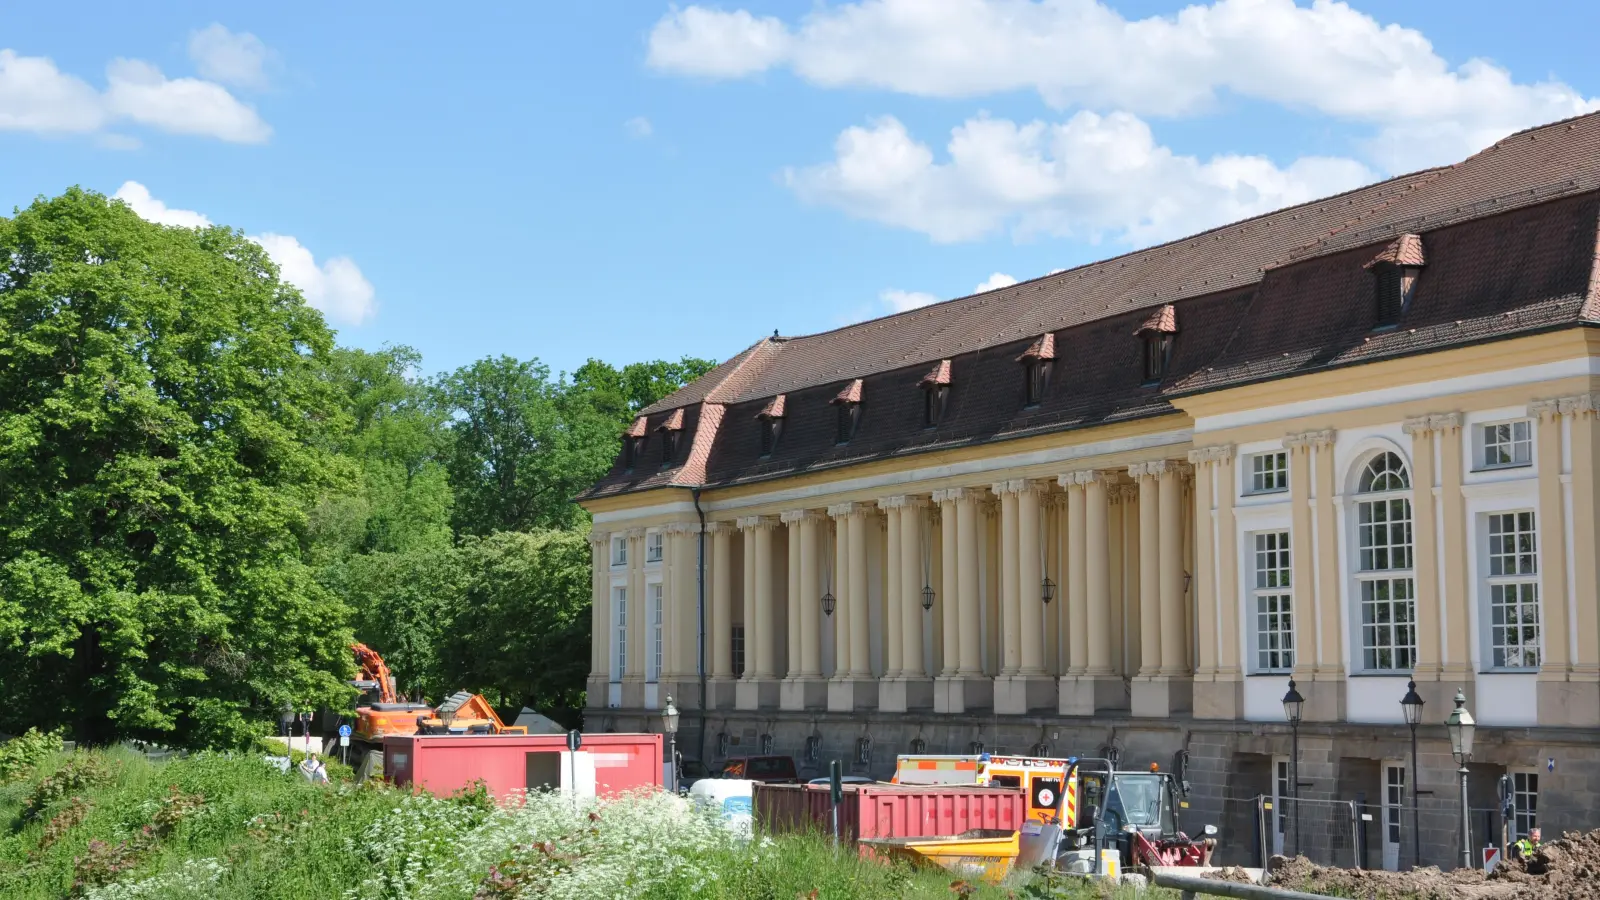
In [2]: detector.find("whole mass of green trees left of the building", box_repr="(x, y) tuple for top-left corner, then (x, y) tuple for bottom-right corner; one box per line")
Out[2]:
(0, 189), (712, 746)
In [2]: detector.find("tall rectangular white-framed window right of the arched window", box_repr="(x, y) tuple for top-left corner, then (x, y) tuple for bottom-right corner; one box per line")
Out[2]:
(1485, 509), (1539, 669)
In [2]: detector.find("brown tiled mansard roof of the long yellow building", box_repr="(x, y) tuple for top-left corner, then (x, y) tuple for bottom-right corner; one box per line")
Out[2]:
(589, 114), (1600, 496)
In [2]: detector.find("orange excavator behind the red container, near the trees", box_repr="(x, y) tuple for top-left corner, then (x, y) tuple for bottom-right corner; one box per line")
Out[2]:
(350, 644), (528, 753)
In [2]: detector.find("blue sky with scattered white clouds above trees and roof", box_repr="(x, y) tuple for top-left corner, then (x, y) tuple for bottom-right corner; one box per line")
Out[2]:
(0, 0), (1600, 372)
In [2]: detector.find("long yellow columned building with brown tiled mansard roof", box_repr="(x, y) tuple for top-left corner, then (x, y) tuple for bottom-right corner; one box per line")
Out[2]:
(581, 117), (1600, 866)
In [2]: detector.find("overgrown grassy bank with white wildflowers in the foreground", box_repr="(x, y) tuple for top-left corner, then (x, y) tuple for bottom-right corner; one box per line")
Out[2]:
(0, 749), (1152, 900)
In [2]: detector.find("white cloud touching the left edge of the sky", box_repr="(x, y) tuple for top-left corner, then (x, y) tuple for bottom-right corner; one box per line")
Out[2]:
(0, 50), (272, 142)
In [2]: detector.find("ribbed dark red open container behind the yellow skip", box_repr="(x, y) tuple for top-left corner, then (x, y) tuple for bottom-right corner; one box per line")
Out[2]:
(755, 785), (1027, 841)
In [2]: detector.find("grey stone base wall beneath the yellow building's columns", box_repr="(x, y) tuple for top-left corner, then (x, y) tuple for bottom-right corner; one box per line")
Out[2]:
(584, 709), (1600, 868)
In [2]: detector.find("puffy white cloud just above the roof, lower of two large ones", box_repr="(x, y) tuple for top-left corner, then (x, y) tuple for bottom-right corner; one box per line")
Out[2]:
(784, 112), (1374, 243)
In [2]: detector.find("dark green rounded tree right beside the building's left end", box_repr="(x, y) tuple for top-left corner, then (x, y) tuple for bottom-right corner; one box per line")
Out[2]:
(440, 528), (590, 721)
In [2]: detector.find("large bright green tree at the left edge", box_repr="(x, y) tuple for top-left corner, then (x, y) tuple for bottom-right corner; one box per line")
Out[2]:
(0, 189), (354, 745)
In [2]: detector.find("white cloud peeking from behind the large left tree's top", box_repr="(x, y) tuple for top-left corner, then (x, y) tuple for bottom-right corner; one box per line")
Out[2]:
(114, 181), (378, 325)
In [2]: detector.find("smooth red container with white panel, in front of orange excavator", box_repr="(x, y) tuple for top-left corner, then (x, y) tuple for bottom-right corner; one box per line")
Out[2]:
(384, 733), (662, 799)
